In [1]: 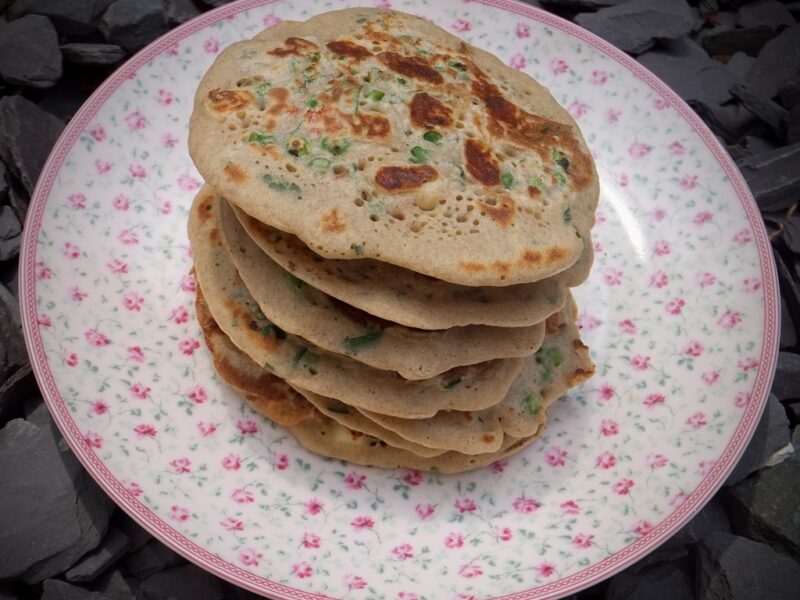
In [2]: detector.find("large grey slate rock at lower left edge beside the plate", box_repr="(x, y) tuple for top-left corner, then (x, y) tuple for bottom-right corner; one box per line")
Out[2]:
(0, 419), (113, 584)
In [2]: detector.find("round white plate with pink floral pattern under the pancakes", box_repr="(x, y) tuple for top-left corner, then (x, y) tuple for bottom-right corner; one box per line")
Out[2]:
(21, 0), (778, 599)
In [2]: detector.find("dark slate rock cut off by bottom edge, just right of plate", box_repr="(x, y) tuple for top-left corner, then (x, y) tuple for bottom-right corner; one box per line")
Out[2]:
(605, 563), (694, 600)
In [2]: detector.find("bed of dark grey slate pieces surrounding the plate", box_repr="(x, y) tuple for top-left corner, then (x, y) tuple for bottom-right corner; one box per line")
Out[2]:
(0, 0), (800, 600)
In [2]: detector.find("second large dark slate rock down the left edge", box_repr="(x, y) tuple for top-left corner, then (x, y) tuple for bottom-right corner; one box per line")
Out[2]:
(0, 95), (64, 194)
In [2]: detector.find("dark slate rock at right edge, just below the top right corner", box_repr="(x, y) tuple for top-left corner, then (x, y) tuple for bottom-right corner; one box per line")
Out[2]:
(746, 25), (800, 98)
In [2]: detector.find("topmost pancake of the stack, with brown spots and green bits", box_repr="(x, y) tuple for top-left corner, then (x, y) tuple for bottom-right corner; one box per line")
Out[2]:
(189, 8), (598, 286)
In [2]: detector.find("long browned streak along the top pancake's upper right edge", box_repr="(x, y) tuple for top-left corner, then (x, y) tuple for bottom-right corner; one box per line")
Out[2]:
(467, 62), (594, 193)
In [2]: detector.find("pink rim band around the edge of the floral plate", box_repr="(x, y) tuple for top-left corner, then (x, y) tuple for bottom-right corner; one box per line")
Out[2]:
(18, 0), (780, 600)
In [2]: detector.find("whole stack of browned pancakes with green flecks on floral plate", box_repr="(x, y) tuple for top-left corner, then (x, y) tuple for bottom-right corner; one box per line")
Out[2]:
(189, 8), (598, 473)
